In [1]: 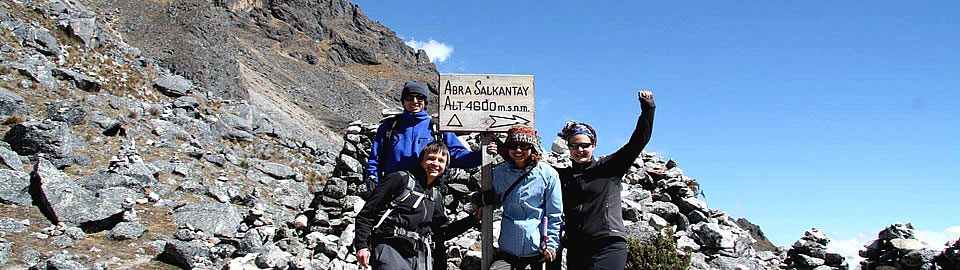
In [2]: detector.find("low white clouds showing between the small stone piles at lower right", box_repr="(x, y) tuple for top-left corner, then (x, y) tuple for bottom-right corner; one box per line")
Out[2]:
(827, 226), (960, 269)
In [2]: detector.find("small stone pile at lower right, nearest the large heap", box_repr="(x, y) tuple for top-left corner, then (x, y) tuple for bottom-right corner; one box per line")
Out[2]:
(781, 228), (849, 270)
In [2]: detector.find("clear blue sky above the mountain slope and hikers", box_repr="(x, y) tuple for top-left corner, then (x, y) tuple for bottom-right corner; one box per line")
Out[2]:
(354, 0), (960, 262)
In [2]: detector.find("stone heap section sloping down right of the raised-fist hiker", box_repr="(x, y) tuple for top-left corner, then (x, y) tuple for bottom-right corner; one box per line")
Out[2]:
(616, 150), (781, 269)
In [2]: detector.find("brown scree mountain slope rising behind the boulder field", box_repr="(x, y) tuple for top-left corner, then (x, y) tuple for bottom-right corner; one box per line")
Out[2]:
(88, 0), (437, 135)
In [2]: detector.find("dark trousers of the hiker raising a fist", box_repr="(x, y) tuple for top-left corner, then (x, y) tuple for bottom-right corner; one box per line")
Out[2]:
(565, 236), (627, 270)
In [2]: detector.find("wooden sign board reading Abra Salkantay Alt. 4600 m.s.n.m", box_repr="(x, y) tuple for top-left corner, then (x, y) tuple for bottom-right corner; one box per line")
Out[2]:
(439, 73), (534, 132)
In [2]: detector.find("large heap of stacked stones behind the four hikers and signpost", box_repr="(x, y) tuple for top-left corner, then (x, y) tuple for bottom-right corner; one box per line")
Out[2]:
(322, 118), (782, 269)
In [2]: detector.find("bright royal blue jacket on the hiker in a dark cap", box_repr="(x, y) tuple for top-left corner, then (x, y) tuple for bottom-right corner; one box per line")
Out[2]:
(363, 110), (480, 184)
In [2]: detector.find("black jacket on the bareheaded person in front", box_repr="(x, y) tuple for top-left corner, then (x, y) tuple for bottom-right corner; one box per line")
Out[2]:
(354, 166), (479, 250)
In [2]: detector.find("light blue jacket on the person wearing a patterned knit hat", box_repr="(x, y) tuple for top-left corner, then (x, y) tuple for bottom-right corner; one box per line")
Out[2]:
(493, 161), (563, 257)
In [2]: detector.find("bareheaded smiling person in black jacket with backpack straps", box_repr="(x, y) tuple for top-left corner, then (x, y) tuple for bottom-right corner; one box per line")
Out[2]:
(354, 141), (479, 270)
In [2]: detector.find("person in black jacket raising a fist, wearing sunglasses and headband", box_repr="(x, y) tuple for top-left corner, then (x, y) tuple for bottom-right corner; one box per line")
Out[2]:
(556, 90), (656, 269)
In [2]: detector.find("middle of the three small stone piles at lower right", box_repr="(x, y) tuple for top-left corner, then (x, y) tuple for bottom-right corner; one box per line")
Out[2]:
(860, 223), (939, 270)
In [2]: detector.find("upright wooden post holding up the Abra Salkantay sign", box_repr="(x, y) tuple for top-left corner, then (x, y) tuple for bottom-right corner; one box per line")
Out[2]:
(480, 136), (496, 270)
